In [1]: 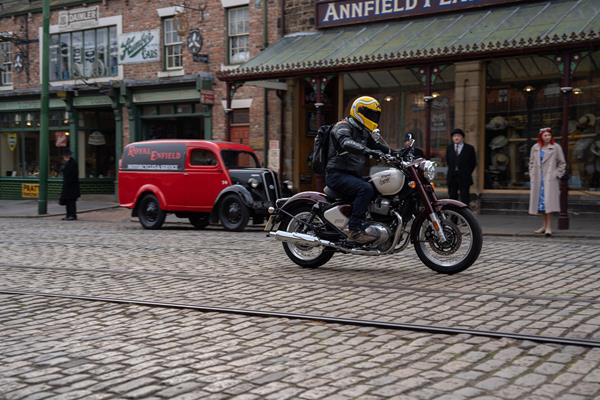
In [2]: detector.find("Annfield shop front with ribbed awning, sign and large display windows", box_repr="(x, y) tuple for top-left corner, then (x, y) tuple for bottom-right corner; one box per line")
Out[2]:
(220, 0), (600, 216)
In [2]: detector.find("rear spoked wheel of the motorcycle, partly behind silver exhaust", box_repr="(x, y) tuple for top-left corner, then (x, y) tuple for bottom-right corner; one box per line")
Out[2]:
(282, 206), (335, 268)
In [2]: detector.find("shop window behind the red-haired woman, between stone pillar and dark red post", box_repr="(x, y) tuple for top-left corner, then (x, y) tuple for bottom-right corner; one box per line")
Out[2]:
(480, 56), (562, 189)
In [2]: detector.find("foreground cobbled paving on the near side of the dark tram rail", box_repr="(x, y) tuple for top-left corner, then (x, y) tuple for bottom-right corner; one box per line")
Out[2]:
(0, 295), (600, 400)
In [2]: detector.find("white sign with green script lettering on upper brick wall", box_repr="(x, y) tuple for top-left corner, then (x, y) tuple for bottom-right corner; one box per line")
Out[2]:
(119, 29), (160, 64)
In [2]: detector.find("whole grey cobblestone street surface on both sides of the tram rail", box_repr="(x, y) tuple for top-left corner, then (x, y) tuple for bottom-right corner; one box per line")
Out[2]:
(0, 210), (600, 399)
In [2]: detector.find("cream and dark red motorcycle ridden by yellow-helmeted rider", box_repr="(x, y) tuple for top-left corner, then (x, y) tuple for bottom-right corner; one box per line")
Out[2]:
(265, 135), (483, 274)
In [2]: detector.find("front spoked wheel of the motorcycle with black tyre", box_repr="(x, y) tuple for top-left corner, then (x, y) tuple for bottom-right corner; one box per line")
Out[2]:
(415, 207), (483, 275)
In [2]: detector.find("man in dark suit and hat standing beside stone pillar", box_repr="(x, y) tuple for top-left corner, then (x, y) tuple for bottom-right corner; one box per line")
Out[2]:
(446, 128), (477, 205)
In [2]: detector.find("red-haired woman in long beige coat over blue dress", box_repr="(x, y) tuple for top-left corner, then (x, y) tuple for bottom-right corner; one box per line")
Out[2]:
(529, 128), (567, 237)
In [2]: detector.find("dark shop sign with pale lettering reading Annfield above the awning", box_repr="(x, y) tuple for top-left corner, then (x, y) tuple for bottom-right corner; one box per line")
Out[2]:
(316, 0), (523, 28)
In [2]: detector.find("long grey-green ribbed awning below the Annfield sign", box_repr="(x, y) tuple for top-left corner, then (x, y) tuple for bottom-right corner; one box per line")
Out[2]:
(219, 0), (600, 81)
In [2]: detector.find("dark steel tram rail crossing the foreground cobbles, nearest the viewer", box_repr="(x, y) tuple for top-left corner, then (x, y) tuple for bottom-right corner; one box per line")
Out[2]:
(0, 288), (600, 348)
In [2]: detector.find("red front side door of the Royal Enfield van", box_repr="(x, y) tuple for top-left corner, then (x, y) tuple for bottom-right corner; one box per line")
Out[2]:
(184, 147), (231, 212)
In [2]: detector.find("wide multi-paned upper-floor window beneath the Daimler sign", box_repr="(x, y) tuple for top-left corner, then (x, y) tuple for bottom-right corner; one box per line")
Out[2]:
(50, 26), (119, 81)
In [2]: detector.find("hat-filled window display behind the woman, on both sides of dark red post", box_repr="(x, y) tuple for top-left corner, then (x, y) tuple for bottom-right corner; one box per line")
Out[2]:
(485, 52), (600, 191)
